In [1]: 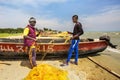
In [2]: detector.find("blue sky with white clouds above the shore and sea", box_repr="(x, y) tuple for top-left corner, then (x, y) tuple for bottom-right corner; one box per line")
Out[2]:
(0, 0), (120, 31)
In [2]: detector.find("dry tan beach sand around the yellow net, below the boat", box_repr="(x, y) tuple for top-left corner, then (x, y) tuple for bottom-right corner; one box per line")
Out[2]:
(0, 52), (120, 80)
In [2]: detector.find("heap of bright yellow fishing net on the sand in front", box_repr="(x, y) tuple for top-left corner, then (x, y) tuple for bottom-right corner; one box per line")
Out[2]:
(24, 64), (69, 80)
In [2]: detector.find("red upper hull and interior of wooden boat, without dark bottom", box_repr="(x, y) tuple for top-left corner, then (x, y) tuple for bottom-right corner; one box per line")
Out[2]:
(0, 38), (108, 55)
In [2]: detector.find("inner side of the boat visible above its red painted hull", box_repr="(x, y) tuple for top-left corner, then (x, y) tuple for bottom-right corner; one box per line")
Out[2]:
(0, 37), (99, 43)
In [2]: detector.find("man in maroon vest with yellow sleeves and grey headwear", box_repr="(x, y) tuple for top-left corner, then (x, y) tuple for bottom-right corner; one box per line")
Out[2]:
(23, 17), (40, 68)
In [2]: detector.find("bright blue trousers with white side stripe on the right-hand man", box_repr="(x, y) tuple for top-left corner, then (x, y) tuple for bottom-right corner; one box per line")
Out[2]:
(67, 40), (80, 62)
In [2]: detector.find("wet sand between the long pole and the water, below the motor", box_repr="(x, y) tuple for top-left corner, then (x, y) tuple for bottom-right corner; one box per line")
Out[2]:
(93, 50), (120, 74)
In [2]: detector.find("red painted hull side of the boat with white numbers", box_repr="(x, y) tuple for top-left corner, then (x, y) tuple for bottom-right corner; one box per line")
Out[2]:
(0, 41), (107, 55)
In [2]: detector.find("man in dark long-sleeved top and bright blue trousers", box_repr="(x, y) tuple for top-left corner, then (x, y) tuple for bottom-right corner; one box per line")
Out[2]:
(61, 15), (84, 66)
